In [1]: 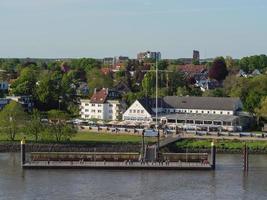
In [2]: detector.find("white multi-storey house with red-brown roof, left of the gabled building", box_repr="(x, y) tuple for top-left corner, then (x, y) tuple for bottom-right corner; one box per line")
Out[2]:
(80, 88), (124, 120)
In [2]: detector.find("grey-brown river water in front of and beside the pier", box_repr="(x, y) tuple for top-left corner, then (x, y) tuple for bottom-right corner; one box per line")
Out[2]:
(0, 153), (267, 200)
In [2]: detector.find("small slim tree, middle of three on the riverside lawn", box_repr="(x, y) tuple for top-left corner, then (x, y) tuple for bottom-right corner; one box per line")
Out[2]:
(26, 109), (45, 142)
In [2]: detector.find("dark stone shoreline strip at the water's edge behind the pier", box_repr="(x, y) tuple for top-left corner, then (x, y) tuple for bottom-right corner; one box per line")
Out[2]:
(0, 142), (267, 154)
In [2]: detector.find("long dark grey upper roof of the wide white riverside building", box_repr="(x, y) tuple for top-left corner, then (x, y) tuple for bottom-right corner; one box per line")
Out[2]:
(163, 96), (240, 110)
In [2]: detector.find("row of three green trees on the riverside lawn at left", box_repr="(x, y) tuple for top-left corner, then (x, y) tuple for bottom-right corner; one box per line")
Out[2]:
(0, 101), (77, 142)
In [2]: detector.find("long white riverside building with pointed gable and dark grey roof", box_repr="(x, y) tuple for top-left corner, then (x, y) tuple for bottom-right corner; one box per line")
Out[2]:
(123, 96), (245, 132)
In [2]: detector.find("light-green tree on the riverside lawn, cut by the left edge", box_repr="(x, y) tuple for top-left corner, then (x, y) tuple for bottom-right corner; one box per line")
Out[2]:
(0, 101), (27, 141)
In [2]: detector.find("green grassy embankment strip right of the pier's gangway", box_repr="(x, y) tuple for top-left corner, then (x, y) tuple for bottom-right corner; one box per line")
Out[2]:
(175, 139), (267, 150)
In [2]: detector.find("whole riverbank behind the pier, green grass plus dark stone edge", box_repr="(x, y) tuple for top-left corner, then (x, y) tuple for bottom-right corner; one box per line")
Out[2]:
(0, 132), (267, 154)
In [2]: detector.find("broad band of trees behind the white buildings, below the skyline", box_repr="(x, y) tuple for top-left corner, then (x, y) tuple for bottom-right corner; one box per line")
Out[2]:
(0, 55), (267, 126)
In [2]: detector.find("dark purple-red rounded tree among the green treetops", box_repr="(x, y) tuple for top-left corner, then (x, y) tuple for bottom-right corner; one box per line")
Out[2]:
(209, 57), (228, 81)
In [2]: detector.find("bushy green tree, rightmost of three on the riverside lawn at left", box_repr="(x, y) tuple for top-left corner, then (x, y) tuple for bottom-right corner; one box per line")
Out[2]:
(48, 110), (77, 142)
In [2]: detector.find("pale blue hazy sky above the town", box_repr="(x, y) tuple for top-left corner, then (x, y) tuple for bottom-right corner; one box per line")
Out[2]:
(0, 0), (267, 58)
